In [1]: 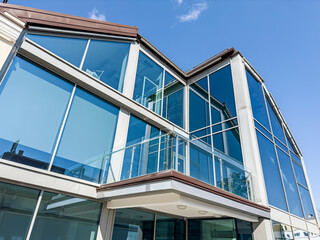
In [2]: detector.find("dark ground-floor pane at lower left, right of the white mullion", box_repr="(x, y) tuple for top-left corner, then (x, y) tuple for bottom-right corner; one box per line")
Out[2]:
(30, 192), (101, 240)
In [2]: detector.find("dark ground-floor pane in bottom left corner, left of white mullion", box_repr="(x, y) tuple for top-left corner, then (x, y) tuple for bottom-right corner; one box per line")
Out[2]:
(0, 183), (40, 240)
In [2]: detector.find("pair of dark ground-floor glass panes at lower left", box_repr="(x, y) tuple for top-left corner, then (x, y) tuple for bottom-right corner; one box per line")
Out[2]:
(0, 183), (102, 240)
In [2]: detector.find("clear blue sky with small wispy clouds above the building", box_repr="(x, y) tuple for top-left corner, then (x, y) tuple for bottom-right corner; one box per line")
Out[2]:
(9, 0), (320, 208)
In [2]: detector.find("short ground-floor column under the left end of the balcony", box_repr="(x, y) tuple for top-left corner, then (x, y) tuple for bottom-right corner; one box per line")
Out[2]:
(96, 202), (116, 240)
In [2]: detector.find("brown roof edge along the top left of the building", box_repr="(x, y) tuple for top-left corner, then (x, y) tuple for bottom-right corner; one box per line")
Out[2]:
(0, 3), (138, 37)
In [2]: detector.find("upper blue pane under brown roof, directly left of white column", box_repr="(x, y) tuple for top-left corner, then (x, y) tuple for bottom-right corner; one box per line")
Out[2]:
(82, 40), (130, 91)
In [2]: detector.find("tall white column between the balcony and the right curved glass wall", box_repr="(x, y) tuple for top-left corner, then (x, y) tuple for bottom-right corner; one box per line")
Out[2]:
(231, 54), (273, 240)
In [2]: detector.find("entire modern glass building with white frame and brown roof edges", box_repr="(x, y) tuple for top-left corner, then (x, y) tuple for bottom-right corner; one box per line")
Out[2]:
(0, 4), (320, 240)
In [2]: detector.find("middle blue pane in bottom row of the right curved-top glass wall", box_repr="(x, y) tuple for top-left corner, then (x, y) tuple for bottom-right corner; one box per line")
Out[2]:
(277, 148), (303, 217)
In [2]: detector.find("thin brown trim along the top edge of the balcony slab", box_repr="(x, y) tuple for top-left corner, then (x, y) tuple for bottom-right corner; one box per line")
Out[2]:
(97, 170), (270, 212)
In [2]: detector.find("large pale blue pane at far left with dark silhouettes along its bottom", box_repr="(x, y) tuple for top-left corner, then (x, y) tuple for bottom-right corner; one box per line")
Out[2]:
(0, 57), (73, 169)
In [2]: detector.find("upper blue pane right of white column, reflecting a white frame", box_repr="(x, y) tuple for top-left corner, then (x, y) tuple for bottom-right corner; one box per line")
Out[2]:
(133, 52), (163, 114)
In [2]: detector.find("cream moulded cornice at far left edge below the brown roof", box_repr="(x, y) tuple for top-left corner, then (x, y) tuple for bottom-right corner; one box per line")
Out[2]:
(0, 12), (25, 69)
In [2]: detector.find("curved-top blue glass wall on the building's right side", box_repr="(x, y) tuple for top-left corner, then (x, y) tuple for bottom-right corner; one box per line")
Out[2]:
(246, 71), (314, 221)
